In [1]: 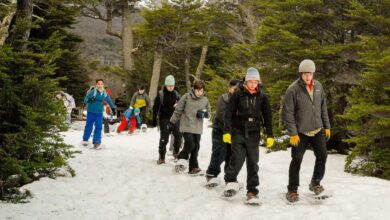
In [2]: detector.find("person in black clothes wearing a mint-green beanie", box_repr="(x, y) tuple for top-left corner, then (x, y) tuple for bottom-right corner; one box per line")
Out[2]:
(152, 75), (182, 164)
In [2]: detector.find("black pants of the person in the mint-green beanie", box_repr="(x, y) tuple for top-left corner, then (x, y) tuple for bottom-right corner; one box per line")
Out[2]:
(158, 119), (182, 159)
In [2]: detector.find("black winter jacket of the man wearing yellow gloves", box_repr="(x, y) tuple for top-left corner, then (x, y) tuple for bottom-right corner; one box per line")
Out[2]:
(224, 85), (273, 137)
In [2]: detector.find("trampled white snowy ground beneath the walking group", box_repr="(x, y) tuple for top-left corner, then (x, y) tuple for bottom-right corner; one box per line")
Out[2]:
(0, 121), (390, 220)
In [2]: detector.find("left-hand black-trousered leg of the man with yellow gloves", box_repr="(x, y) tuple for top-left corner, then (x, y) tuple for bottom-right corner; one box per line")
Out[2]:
(225, 134), (246, 183)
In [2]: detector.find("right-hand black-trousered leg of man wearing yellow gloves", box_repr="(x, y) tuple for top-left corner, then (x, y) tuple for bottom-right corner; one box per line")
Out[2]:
(245, 133), (260, 195)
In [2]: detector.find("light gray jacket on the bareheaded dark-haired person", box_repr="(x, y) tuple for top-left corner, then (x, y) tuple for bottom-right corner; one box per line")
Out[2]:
(170, 91), (211, 134)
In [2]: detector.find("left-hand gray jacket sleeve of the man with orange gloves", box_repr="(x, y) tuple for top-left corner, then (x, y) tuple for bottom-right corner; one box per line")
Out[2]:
(283, 88), (298, 136)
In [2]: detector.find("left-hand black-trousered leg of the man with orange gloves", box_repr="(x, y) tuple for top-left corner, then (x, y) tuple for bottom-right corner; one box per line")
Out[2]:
(287, 134), (309, 192)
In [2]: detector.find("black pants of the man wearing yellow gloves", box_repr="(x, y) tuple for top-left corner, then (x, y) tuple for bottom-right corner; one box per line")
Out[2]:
(225, 131), (260, 195)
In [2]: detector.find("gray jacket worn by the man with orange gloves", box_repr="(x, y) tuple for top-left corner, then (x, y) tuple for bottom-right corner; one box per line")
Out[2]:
(283, 79), (330, 135)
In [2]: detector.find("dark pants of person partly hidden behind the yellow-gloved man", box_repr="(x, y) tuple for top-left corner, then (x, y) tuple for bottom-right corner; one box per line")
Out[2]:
(206, 128), (232, 177)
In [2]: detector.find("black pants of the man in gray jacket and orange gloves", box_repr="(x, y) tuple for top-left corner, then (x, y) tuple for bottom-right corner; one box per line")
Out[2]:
(287, 130), (327, 191)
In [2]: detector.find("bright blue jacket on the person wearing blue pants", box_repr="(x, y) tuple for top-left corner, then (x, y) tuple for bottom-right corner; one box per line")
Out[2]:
(84, 88), (116, 113)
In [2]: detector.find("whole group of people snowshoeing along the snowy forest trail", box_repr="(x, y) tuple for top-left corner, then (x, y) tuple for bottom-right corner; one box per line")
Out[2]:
(83, 59), (330, 205)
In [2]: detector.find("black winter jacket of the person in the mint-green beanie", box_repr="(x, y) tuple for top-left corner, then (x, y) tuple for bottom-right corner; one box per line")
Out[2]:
(153, 86), (180, 123)
